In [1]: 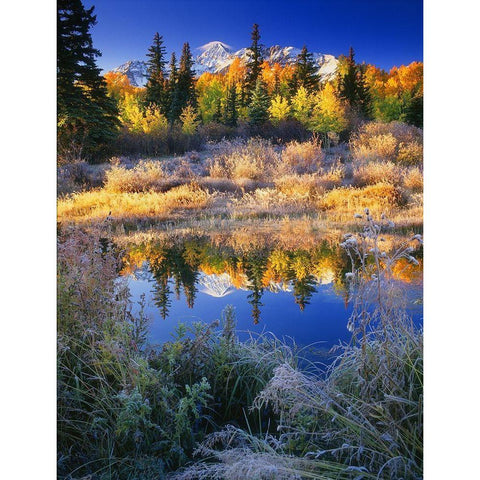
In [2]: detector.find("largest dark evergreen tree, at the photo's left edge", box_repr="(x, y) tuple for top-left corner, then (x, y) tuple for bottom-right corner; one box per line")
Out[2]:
(57, 0), (119, 159)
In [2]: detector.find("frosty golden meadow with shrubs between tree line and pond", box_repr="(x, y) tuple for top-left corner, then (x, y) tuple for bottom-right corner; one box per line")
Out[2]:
(58, 122), (423, 231)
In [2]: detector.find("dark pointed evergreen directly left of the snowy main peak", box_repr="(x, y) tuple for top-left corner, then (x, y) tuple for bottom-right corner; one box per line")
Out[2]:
(170, 43), (197, 121)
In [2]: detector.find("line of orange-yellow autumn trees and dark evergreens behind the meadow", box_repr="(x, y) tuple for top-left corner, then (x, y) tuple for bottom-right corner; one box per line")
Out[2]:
(57, 0), (423, 163)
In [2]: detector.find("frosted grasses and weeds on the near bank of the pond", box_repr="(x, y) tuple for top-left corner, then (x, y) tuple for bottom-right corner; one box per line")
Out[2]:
(58, 212), (423, 479)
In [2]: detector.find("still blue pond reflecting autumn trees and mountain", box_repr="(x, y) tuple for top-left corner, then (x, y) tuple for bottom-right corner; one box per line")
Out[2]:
(122, 236), (423, 351)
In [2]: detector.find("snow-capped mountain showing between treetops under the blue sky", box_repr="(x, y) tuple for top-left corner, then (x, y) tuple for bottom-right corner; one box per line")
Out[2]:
(114, 41), (338, 87)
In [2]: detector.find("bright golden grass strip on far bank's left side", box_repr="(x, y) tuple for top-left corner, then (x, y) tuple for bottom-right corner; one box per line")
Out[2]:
(57, 184), (214, 221)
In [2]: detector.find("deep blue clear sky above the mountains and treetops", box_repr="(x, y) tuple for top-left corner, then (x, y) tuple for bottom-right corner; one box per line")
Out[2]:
(84, 0), (423, 70)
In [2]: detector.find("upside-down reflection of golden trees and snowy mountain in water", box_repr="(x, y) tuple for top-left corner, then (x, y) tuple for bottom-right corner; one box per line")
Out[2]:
(122, 236), (422, 324)
